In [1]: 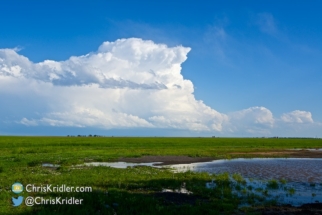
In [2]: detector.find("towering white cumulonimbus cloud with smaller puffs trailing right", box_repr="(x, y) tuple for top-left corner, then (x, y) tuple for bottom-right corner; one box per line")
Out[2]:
(0, 38), (313, 134)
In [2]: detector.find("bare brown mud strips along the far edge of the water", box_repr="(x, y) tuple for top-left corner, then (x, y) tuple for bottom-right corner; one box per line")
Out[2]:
(117, 150), (322, 166)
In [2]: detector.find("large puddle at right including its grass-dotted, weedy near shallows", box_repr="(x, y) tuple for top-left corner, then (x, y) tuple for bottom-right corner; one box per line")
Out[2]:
(169, 158), (322, 206)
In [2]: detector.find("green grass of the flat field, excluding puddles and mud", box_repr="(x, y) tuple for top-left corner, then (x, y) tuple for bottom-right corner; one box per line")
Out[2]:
(0, 136), (322, 214)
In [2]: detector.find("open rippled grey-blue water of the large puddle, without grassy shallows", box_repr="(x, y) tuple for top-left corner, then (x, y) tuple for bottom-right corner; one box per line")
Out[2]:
(169, 158), (322, 183)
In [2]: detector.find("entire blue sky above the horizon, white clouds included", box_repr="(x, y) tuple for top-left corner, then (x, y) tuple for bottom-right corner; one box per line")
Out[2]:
(0, 0), (322, 137)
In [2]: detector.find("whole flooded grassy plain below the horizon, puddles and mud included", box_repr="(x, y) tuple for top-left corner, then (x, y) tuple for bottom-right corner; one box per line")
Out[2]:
(0, 136), (322, 215)
